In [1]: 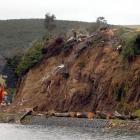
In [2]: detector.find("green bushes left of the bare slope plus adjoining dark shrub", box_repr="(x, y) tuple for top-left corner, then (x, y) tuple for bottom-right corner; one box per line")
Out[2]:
(7, 40), (44, 77)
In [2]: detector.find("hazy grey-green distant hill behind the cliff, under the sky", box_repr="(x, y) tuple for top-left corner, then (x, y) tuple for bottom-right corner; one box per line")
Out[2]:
(0, 19), (91, 57)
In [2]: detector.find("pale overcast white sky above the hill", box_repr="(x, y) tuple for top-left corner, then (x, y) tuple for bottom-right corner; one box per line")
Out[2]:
(0, 0), (140, 25)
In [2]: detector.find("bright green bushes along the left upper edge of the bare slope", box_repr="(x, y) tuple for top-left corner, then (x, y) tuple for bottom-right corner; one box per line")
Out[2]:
(16, 41), (44, 76)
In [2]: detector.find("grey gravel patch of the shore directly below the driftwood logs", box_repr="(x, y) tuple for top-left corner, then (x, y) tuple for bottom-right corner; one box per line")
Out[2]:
(31, 116), (109, 128)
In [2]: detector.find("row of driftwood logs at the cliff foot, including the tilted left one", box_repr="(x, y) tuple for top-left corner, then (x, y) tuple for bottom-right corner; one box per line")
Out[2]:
(16, 107), (137, 123)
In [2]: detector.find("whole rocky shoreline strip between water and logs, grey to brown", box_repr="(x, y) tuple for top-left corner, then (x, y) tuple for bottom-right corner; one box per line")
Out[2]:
(0, 113), (140, 132)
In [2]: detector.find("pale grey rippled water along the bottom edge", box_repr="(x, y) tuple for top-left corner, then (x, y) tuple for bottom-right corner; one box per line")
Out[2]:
(0, 124), (140, 140)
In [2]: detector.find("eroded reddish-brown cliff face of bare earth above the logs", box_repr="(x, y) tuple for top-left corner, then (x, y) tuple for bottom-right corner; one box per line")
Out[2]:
(10, 30), (140, 112)
